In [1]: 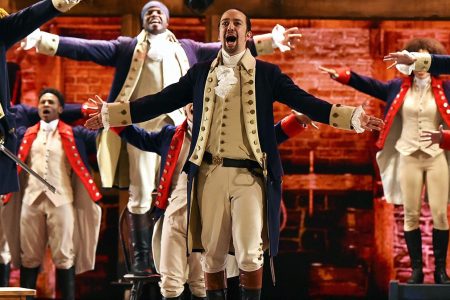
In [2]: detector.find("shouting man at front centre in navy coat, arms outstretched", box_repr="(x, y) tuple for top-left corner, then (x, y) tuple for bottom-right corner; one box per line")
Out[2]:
(86, 9), (383, 299)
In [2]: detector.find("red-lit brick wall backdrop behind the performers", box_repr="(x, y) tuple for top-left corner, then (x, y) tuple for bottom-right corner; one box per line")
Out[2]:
(8, 17), (450, 295)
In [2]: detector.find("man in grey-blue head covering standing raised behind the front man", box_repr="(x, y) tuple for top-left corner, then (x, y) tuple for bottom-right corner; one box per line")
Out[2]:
(29, 1), (302, 275)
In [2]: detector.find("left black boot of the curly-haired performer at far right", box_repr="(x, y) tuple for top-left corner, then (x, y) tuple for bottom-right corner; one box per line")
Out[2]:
(405, 228), (424, 284)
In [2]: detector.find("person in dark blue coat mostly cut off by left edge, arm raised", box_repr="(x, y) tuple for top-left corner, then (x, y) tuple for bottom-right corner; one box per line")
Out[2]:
(0, 0), (80, 195)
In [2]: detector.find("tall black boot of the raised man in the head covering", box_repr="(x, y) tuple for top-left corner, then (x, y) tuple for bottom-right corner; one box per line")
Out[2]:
(128, 212), (155, 276)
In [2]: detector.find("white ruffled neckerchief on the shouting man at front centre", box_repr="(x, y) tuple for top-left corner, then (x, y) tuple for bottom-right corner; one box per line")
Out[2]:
(214, 49), (245, 98)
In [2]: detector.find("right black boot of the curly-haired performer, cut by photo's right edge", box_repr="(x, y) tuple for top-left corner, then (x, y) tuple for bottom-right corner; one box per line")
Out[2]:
(433, 229), (450, 284)
